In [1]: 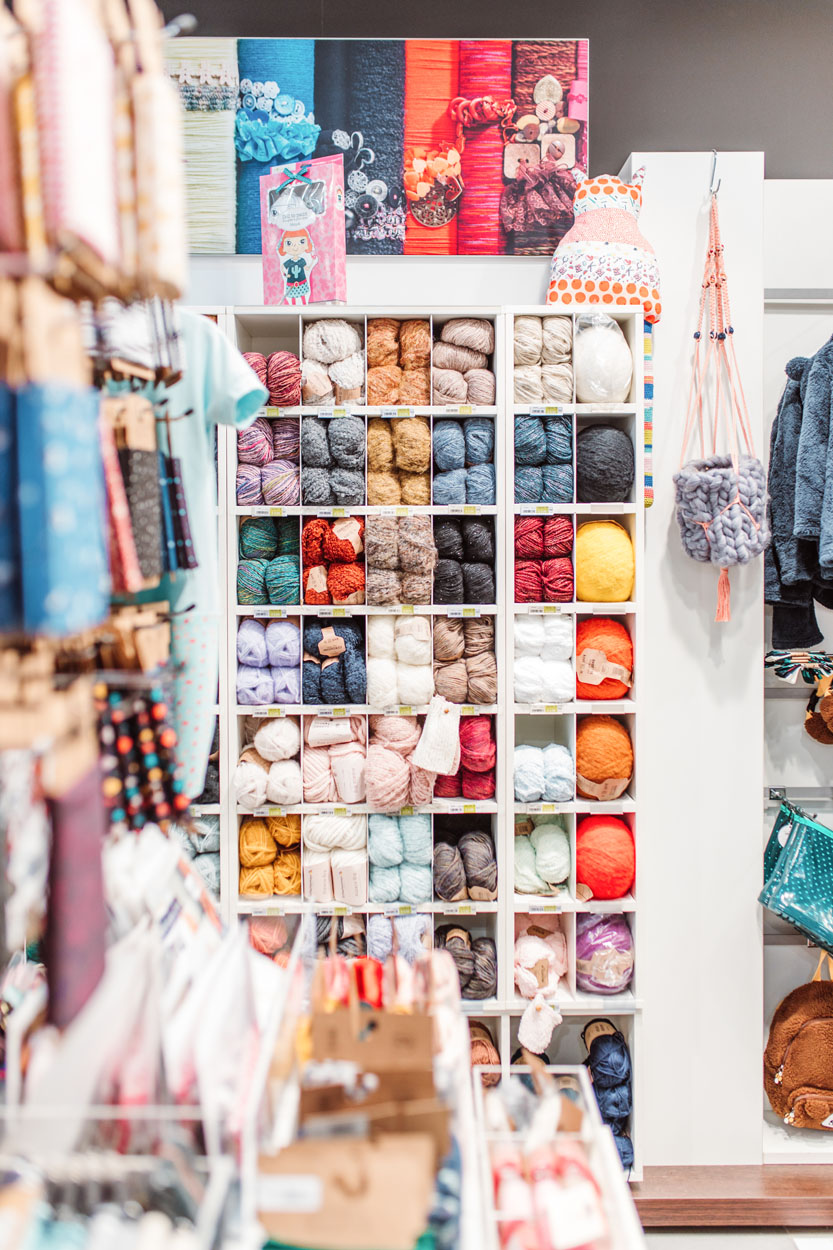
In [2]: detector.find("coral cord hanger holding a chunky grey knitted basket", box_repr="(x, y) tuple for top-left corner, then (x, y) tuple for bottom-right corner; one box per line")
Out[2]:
(674, 153), (769, 621)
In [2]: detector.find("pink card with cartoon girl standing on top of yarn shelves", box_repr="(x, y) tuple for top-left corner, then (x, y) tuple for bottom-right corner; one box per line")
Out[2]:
(260, 156), (346, 305)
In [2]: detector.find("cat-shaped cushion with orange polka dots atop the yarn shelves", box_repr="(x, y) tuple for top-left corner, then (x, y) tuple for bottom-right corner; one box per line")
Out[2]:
(547, 169), (663, 321)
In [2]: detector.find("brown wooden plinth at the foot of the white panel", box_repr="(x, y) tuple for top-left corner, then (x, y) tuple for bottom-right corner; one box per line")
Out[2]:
(630, 1164), (833, 1229)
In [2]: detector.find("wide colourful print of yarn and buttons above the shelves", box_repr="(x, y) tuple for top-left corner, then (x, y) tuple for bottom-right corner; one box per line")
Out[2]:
(166, 39), (589, 256)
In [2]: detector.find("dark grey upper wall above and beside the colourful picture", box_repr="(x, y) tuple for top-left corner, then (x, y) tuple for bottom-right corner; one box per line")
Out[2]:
(168, 0), (833, 178)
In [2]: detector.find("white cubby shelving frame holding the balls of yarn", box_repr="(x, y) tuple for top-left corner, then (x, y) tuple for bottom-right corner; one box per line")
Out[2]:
(206, 305), (644, 1179)
